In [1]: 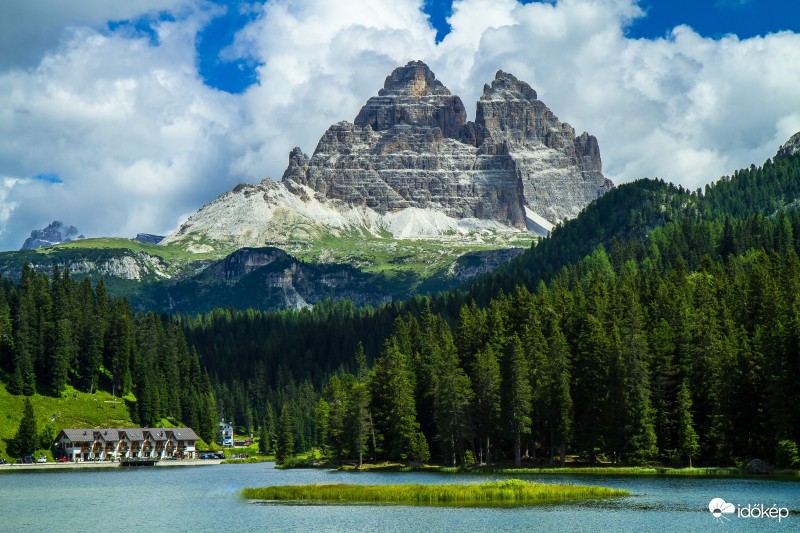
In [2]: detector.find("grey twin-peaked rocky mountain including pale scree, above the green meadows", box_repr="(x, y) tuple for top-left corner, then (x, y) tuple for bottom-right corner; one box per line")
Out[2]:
(164, 61), (612, 252)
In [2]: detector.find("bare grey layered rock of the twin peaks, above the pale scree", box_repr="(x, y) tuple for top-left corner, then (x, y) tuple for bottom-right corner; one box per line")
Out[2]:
(283, 61), (612, 229)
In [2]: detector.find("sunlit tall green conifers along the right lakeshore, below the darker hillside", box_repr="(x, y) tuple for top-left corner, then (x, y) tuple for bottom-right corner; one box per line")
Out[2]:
(278, 237), (800, 466)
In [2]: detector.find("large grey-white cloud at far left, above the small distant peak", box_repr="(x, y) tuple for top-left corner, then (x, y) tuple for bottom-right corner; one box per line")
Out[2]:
(0, 4), (238, 248)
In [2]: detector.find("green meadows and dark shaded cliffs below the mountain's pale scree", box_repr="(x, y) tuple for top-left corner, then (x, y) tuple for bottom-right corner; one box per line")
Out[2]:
(0, 234), (533, 312)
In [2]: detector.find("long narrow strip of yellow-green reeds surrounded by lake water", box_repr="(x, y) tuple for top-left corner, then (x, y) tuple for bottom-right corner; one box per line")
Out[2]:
(243, 479), (630, 507)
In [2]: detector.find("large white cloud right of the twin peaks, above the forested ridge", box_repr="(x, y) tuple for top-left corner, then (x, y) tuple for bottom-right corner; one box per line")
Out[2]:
(428, 0), (800, 188)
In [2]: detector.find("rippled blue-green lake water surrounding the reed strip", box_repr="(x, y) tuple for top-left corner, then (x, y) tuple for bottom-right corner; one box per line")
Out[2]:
(0, 463), (800, 532)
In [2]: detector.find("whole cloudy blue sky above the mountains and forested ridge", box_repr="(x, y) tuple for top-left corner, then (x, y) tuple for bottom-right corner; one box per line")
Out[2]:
(0, 0), (800, 249)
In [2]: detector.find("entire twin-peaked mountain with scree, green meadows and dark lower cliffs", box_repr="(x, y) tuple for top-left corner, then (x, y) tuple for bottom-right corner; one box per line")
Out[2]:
(0, 62), (612, 312)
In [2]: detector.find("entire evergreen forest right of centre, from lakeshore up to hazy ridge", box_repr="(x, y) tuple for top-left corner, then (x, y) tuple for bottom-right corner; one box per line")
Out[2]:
(181, 151), (800, 465)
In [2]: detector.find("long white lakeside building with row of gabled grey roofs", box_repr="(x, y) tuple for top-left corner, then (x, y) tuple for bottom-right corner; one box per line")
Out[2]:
(54, 428), (200, 461)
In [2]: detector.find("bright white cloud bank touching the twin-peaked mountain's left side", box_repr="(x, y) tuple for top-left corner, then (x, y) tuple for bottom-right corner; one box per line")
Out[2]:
(227, 0), (435, 178)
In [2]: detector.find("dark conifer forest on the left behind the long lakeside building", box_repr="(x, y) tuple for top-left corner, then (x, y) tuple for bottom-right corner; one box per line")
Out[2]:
(0, 266), (218, 442)
